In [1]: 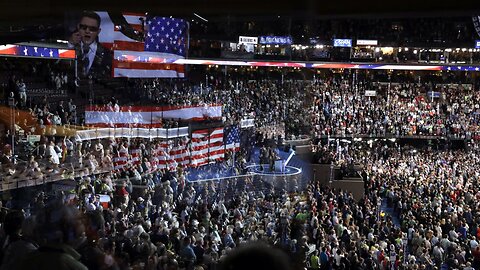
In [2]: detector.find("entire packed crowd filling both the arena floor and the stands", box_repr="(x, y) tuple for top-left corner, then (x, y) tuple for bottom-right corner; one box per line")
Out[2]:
(0, 58), (480, 270)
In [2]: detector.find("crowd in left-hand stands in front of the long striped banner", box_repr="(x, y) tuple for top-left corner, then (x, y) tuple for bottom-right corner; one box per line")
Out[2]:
(0, 133), (253, 192)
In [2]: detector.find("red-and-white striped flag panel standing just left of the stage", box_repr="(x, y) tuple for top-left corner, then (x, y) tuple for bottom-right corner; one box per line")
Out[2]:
(190, 127), (225, 167)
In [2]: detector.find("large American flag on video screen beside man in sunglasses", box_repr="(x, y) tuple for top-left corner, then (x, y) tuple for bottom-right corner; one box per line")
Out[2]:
(97, 12), (188, 78)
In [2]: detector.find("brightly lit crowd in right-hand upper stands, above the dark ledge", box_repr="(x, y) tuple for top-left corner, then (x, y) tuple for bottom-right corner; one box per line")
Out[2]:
(312, 77), (479, 138)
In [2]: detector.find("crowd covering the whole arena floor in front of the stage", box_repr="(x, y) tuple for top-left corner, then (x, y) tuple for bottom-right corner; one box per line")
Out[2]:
(1, 136), (480, 270)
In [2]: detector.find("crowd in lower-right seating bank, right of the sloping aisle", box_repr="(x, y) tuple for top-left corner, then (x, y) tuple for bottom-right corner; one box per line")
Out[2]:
(354, 142), (480, 269)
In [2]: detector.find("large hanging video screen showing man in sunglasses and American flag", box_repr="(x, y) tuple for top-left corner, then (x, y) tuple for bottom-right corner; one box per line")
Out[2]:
(66, 11), (189, 78)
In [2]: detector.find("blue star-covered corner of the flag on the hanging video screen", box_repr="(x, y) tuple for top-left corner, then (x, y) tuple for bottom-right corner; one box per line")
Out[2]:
(145, 17), (188, 57)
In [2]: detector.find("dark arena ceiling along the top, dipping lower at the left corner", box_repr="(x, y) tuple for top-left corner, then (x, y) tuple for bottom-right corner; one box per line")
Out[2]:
(0, 0), (480, 43)
